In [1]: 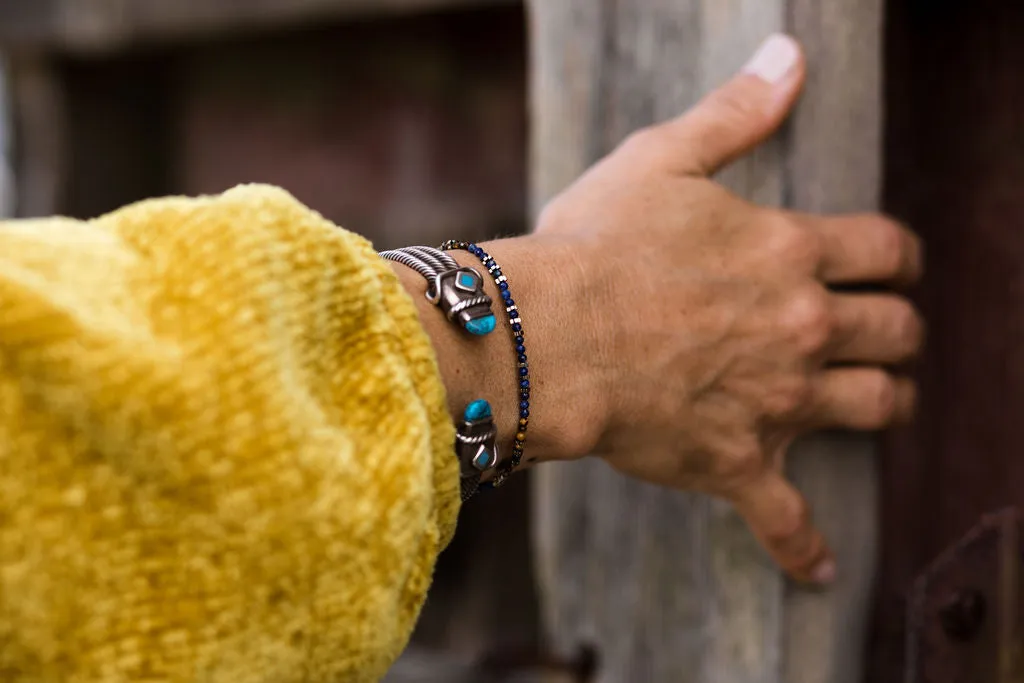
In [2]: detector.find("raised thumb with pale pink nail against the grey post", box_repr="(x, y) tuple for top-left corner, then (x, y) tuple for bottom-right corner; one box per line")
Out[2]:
(664, 34), (805, 175)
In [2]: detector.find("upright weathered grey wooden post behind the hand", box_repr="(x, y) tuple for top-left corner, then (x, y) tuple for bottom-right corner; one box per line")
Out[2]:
(529, 0), (882, 683)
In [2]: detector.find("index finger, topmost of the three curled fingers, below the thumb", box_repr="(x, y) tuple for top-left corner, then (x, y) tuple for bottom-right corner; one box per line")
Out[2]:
(793, 214), (923, 285)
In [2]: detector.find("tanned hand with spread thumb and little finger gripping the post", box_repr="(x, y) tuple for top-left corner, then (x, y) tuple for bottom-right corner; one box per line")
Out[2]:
(537, 38), (923, 583)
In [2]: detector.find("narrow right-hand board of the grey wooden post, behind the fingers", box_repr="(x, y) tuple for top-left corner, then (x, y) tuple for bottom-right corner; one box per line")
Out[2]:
(782, 0), (884, 683)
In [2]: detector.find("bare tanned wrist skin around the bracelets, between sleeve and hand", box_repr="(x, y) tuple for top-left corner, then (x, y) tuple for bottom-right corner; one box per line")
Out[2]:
(392, 236), (604, 464)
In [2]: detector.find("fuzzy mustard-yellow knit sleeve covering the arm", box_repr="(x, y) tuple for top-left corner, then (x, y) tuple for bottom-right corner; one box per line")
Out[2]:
(0, 186), (459, 683)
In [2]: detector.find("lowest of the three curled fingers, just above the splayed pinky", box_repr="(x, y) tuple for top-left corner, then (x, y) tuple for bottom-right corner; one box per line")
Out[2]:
(807, 368), (918, 431)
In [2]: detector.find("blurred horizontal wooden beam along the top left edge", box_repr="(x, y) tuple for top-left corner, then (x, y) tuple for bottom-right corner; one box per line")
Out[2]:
(0, 0), (516, 51)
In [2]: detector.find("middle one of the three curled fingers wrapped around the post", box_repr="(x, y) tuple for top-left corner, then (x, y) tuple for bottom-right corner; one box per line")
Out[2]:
(828, 294), (925, 365)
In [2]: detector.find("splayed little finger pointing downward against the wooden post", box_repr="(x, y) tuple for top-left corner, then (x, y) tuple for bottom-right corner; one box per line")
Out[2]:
(733, 470), (836, 584)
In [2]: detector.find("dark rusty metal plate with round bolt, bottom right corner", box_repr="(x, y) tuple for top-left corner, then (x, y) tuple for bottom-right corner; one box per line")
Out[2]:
(904, 509), (1024, 683)
